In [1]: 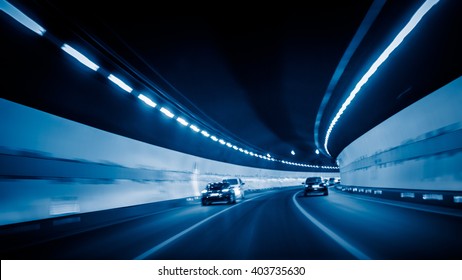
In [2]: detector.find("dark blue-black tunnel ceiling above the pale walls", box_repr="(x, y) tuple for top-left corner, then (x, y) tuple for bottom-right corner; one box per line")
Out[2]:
(2, 0), (462, 170)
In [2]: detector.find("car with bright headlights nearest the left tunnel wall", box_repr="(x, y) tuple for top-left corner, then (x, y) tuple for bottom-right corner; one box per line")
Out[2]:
(201, 181), (244, 206)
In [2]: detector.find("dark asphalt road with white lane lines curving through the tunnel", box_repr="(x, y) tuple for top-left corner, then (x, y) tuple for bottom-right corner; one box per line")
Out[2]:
(2, 188), (462, 260)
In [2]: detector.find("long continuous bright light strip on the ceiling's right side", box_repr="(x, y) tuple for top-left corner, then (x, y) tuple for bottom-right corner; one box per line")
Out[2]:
(324, 0), (439, 155)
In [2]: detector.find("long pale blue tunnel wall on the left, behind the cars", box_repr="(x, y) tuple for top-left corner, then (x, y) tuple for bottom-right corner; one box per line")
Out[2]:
(0, 99), (338, 225)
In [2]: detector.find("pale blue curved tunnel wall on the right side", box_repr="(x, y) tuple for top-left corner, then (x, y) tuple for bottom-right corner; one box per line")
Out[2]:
(337, 77), (462, 191)
